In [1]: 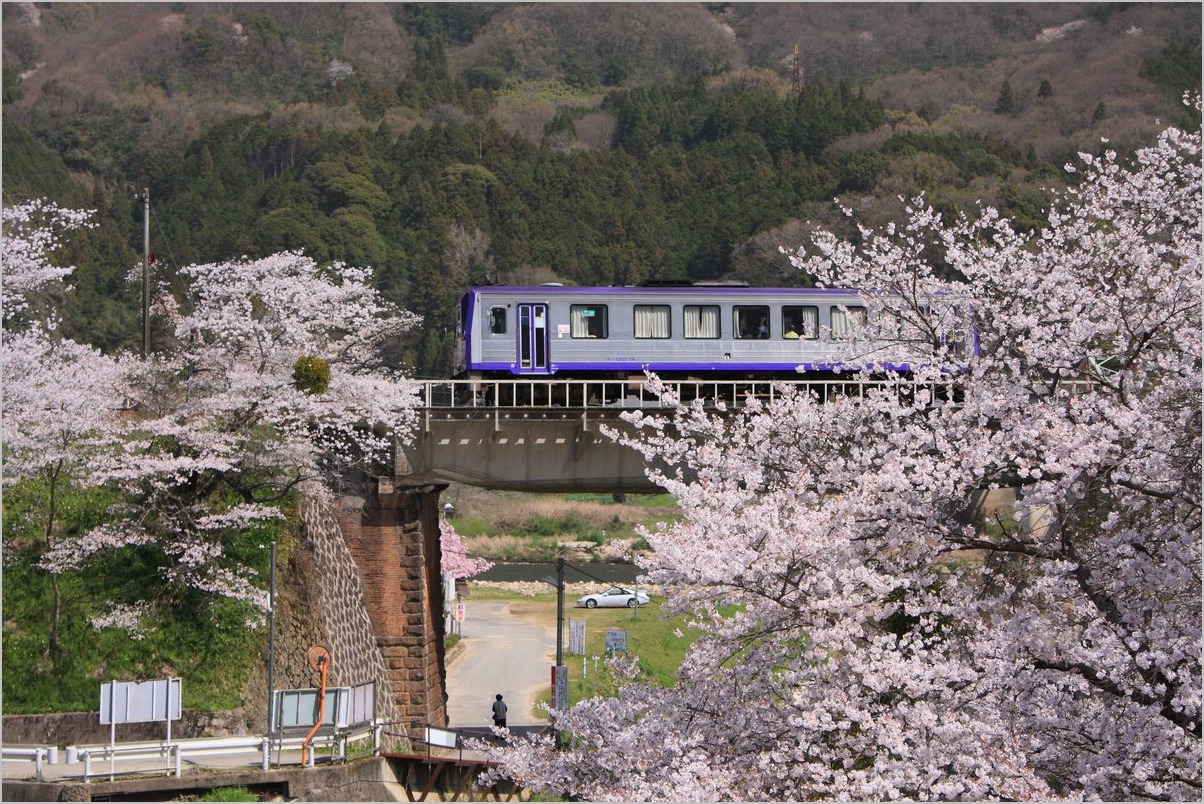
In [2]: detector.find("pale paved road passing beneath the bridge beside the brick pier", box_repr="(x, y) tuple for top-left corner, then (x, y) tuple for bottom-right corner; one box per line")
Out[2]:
(448, 598), (556, 728)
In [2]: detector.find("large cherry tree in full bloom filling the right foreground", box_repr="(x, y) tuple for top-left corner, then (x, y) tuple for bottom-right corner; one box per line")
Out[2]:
(490, 114), (1202, 800)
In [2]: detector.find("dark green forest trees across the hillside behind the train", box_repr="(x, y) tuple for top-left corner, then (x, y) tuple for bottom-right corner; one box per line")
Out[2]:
(2, 10), (1083, 377)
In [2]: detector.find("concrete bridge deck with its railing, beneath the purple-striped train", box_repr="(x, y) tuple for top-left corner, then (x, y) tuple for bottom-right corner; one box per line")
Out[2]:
(394, 377), (951, 493)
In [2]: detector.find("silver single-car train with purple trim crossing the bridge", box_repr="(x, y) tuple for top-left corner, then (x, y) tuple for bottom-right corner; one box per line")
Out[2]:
(453, 284), (978, 383)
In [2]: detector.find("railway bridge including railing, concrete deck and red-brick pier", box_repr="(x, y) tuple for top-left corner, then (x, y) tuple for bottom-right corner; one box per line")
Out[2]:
(329, 378), (977, 735)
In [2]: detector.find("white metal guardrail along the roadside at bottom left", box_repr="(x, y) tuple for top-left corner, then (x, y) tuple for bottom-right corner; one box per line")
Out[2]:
(2, 723), (382, 782)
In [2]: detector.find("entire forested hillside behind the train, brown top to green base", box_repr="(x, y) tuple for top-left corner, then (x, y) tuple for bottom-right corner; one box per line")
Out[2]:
(2, 4), (1200, 376)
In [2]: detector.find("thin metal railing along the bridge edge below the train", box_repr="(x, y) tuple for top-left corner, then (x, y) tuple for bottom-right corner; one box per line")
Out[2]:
(420, 376), (955, 410)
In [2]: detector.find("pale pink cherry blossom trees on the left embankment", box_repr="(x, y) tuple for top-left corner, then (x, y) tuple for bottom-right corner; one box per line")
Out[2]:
(4, 206), (417, 633)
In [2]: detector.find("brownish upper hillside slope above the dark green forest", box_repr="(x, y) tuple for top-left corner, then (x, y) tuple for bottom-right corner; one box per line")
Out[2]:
(4, 2), (1200, 164)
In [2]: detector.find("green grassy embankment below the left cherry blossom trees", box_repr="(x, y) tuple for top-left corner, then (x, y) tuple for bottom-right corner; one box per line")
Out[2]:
(0, 480), (282, 714)
